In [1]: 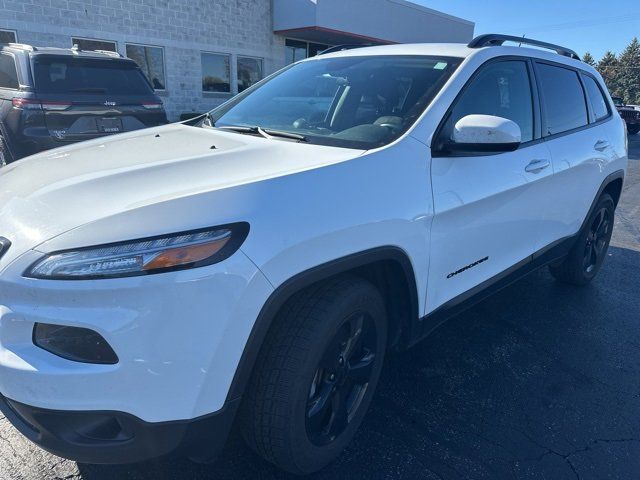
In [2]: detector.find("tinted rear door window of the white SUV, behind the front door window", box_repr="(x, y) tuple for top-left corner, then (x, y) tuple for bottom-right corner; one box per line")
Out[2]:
(538, 63), (589, 136)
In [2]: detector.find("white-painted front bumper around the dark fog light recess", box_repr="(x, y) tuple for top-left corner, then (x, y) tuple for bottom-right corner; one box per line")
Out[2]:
(0, 251), (273, 423)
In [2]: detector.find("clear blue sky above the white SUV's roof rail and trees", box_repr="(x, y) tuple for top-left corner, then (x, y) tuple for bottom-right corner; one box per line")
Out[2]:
(413, 0), (640, 60)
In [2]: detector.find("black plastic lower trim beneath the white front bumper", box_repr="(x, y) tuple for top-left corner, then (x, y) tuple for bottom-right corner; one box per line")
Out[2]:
(0, 395), (239, 464)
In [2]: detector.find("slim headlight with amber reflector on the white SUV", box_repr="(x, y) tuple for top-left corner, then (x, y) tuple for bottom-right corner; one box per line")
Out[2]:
(25, 223), (249, 280)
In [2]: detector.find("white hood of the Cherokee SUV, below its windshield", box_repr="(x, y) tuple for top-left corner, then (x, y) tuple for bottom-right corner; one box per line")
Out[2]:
(0, 124), (362, 268)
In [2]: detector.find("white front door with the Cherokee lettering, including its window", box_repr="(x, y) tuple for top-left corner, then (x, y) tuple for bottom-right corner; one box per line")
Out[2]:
(427, 59), (553, 312)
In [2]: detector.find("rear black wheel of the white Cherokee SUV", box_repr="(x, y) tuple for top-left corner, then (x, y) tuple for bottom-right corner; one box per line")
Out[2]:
(549, 193), (615, 285)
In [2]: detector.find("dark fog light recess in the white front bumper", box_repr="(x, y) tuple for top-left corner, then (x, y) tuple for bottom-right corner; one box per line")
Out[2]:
(33, 323), (118, 365)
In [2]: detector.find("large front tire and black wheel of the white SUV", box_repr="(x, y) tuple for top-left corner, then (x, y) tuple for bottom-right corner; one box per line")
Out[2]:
(241, 276), (387, 474)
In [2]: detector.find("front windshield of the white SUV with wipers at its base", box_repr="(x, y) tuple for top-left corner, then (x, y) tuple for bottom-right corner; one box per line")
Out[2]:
(209, 56), (460, 149)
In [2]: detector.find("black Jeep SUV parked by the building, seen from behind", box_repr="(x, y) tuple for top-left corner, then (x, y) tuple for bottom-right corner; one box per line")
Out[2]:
(0, 44), (167, 166)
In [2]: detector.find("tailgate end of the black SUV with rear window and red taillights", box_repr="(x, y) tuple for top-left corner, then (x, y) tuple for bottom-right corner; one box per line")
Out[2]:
(33, 55), (166, 142)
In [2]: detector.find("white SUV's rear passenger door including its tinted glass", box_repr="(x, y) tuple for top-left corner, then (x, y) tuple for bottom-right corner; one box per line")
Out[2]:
(535, 61), (615, 250)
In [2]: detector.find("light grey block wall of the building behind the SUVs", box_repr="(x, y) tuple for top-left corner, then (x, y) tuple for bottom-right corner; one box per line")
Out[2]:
(0, 0), (285, 120)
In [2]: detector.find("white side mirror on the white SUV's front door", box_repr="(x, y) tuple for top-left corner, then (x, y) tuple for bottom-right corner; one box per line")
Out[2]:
(448, 115), (522, 152)
